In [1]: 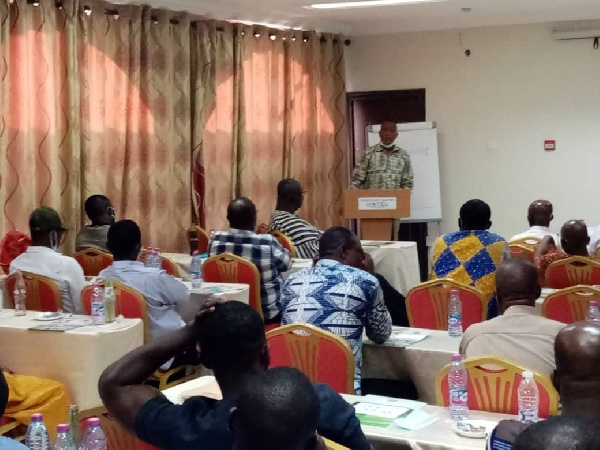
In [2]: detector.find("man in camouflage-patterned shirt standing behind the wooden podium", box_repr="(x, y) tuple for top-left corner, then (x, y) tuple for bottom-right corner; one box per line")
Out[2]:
(350, 120), (413, 189)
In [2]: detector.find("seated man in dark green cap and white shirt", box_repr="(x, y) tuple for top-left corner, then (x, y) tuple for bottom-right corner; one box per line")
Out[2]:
(10, 206), (85, 314)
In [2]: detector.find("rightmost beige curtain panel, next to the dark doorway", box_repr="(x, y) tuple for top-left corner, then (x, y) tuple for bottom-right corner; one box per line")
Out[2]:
(192, 25), (347, 229)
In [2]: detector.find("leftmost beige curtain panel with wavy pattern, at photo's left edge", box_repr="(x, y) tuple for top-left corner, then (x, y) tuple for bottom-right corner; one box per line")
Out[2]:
(0, 0), (81, 250)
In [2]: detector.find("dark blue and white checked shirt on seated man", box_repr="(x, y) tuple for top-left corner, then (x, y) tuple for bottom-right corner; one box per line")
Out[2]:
(208, 228), (292, 320)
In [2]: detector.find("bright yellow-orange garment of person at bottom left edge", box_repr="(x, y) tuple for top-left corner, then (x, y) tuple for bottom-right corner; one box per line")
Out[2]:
(0, 371), (71, 442)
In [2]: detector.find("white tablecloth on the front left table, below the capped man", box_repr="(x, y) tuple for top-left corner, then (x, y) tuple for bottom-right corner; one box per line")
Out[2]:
(0, 310), (144, 411)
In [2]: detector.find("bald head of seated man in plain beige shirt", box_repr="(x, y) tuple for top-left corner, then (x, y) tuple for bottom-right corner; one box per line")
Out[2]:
(496, 258), (542, 313)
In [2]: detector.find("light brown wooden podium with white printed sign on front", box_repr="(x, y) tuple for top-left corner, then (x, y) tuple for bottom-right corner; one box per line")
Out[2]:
(344, 189), (411, 241)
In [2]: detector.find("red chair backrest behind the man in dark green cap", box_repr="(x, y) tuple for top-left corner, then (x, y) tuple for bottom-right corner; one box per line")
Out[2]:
(6, 272), (62, 312)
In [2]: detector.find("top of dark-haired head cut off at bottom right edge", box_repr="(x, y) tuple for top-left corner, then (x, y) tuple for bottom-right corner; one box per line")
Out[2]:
(512, 416), (600, 450)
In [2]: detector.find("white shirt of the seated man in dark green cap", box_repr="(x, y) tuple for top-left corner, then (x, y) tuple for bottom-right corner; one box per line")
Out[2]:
(10, 245), (85, 314)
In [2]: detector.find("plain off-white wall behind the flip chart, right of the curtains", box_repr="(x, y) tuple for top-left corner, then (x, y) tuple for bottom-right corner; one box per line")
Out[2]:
(346, 24), (600, 238)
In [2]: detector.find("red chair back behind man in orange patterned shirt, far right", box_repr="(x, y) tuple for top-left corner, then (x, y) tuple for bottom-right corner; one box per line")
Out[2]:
(545, 256), (600, 289)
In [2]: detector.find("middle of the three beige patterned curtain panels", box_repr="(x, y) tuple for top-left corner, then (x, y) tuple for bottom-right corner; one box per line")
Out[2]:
(79, 1), (192, 252)
